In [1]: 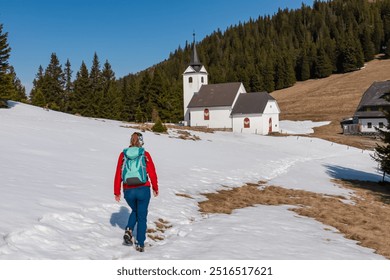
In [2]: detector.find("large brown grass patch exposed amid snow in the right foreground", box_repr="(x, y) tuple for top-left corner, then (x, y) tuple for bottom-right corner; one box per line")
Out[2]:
(199, 180), (390, 259)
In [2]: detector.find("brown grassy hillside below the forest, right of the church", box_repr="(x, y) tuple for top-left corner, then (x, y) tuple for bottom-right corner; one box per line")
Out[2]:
(271, 59), (390, 149)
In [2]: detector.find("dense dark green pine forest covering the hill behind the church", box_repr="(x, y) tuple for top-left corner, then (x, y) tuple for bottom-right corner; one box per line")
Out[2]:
(0, 0), (390, 122)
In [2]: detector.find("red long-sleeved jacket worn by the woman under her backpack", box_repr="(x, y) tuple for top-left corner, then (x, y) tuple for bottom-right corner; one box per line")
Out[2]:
(114, 151), (158, 195)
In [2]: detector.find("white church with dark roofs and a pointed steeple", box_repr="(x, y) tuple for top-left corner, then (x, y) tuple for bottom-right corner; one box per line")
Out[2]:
(183, 41), (280, 135)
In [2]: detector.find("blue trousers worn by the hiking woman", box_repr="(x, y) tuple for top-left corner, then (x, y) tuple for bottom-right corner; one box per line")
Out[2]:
(124, 187), (150, 246)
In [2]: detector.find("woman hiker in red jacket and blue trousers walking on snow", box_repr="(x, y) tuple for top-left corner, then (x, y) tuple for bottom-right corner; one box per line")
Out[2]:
(114, 132), (158, 252)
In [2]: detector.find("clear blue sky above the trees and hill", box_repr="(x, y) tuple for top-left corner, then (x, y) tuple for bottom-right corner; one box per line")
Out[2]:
(0, 0), (313, 94)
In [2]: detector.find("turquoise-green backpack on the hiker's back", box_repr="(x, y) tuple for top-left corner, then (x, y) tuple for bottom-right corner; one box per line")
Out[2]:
(122, 147), (148, 186)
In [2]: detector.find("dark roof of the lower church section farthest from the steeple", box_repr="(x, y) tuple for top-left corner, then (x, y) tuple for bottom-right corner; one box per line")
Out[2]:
(231, 91), (275, 115)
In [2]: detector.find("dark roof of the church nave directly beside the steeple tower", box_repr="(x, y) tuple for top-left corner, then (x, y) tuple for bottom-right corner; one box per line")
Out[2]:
(188, 83), (241, 108)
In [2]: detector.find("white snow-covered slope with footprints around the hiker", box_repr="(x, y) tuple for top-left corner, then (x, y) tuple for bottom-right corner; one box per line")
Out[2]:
(0, 103), (384, 260)
